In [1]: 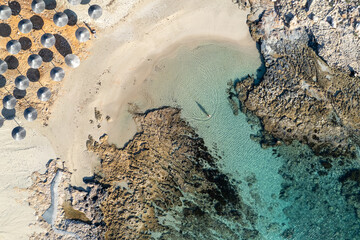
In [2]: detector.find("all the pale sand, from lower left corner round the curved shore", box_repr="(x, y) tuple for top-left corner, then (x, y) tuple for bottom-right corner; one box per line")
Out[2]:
(0, 0), (255, 239)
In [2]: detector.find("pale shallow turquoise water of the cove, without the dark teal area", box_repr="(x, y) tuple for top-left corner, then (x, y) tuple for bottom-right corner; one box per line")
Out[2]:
(110, 42), (286, 239)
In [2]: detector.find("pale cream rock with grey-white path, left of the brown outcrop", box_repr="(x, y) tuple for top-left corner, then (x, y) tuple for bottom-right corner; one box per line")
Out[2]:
(28, 159), (106, 240)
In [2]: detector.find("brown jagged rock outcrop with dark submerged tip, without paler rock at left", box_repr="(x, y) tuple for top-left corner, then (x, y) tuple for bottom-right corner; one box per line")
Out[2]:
(87, 107), (259, 239)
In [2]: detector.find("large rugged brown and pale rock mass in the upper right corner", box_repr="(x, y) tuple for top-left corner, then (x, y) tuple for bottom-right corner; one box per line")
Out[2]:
(234, 0), (360, 157)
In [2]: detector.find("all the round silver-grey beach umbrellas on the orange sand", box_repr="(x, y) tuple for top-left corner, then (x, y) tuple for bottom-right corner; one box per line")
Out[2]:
(0, 0), (102, 140)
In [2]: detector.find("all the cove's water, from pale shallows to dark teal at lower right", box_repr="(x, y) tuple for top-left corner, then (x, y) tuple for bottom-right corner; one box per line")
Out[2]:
(114, 43), (360, 239)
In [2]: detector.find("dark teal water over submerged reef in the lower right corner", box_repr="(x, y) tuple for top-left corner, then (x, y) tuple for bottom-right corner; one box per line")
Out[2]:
(274, 142), (360, 239)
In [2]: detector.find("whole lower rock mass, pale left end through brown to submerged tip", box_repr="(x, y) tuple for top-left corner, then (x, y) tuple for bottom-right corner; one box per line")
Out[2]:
(28, 107), (261, 239)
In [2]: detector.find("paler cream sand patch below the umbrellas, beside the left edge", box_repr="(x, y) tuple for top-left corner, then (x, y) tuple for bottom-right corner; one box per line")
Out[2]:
(0, 121), (56, 240)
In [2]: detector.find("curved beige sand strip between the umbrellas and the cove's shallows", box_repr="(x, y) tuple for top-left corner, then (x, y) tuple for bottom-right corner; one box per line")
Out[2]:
(45, 0), (255, 185)
